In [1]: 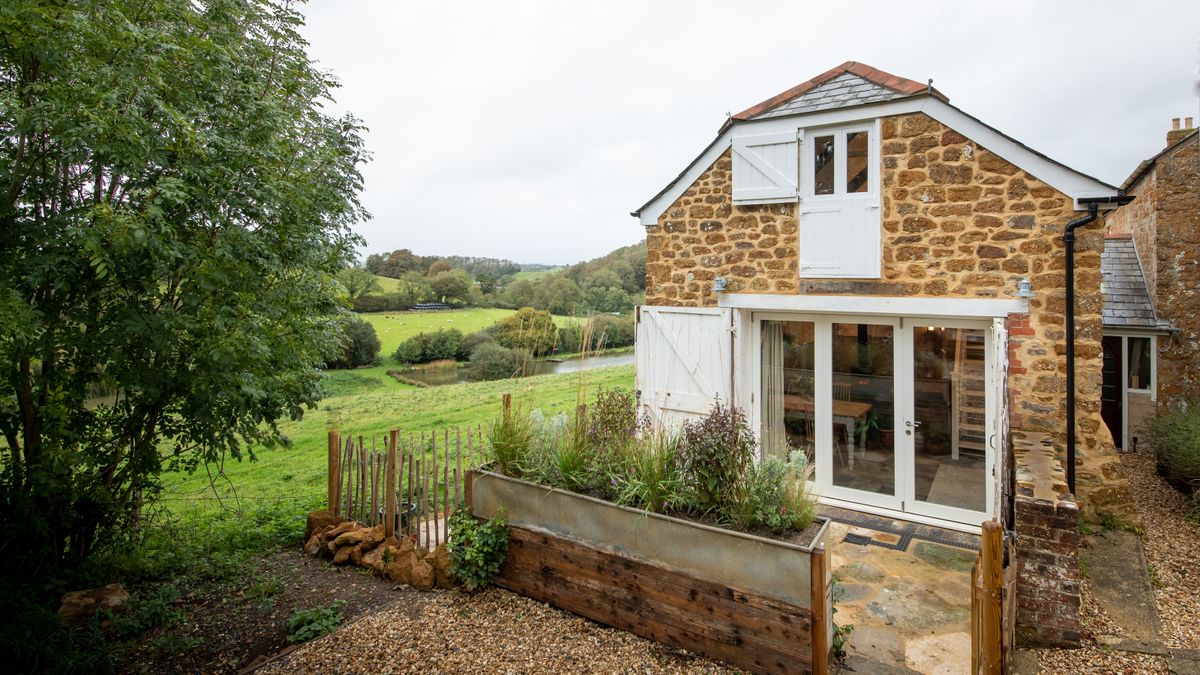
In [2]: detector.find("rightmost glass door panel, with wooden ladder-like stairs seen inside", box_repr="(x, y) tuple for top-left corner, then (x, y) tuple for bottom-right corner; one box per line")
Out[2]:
(906, 325), (988, 512)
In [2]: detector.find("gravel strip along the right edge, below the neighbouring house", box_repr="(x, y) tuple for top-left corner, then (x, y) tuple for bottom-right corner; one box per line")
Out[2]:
(1121, 450), (1200, 649)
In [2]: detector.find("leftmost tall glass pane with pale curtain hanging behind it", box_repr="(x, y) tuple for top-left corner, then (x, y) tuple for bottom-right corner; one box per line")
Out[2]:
(760, 321), (816, 462)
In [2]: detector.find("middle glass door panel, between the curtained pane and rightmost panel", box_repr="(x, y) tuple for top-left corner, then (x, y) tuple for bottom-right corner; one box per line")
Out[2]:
(828, 323), (896, 496)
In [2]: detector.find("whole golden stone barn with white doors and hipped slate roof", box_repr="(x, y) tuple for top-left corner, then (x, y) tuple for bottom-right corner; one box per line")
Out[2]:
(632, 61), (1136, 644)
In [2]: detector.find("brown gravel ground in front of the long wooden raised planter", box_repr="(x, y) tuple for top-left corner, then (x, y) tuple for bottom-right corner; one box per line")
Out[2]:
(257, 589), (736, 674)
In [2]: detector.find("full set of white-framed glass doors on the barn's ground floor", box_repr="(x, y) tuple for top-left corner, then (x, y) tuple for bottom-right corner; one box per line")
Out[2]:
(756, 315), (991, 525)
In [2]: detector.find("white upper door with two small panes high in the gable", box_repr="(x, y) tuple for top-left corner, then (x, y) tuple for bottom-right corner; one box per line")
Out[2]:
(799, 124), (882, 279)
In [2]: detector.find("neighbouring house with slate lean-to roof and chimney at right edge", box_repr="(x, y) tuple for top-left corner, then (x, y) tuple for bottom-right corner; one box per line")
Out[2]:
(1103, 118), (1200, 448)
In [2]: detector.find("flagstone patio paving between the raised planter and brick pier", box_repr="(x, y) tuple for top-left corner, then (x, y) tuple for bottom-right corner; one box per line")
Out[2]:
(828, 522), (976, 674)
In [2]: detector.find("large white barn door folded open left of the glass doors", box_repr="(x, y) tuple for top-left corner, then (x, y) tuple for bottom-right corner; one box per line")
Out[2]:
(634, 306), (733, 426)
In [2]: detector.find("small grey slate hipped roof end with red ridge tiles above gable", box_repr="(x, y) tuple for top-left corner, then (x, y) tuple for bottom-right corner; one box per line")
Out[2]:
(731, 61), (949, 121)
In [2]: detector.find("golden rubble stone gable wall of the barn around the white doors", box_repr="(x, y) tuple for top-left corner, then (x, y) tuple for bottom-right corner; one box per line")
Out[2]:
(646, 113), (1136, 521)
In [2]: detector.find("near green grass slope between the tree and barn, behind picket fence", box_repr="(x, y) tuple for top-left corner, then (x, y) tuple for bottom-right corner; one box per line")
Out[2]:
(162, 366), (634, 519)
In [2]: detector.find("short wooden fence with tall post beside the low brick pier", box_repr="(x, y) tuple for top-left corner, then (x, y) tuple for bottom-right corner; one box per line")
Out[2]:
(971, 520), (1016, 675)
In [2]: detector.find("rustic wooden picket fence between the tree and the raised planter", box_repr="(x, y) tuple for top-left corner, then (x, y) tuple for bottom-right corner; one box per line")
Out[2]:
(328, 428), (484, 548)
